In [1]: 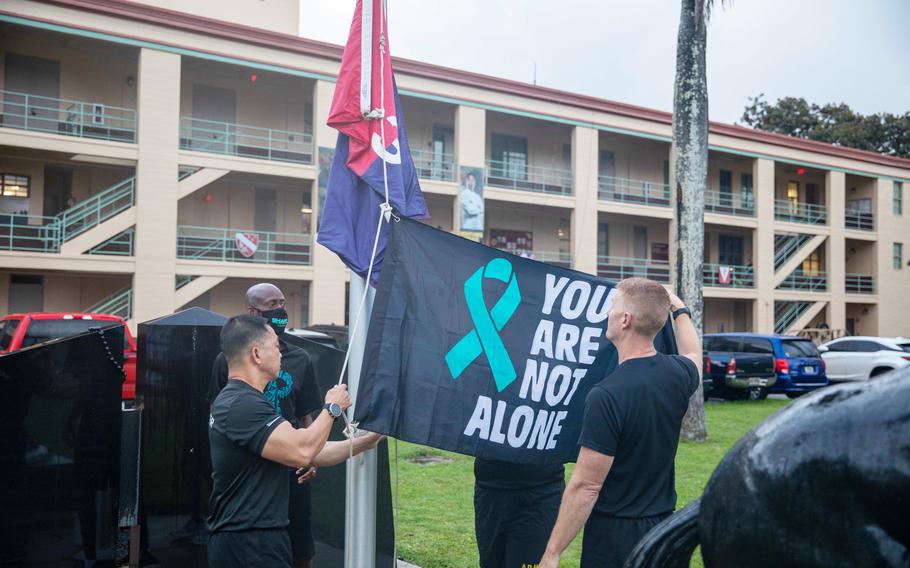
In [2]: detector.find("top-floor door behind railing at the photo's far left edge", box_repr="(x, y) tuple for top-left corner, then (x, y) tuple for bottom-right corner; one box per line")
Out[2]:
(3, 52), (65, 132)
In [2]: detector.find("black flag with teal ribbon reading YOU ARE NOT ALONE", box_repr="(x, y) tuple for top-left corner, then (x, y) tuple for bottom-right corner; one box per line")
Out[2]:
(354, 218), (676, 464)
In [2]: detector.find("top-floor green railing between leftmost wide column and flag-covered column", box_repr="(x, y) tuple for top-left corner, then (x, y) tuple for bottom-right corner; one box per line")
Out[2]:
(180, 116), (313, 164)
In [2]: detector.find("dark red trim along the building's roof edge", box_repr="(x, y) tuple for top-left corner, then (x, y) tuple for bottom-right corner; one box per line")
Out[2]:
(19, 0), (910, 169)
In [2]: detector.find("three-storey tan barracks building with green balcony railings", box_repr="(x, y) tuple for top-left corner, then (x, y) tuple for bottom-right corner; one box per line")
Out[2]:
(0, 0), (910, 336)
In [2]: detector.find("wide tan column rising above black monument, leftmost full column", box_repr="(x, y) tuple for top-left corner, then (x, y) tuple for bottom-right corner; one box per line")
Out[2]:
(133, 48), (181, 322)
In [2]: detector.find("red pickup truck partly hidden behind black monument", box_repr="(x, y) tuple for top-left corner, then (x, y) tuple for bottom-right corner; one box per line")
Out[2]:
(0, 312), (136, 403)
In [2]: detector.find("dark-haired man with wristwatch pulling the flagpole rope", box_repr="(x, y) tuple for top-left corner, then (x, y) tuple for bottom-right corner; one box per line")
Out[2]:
(208, 315), (363, 568)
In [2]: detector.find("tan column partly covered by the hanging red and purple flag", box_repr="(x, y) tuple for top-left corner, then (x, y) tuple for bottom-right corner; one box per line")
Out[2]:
(310, 81), (346, 325)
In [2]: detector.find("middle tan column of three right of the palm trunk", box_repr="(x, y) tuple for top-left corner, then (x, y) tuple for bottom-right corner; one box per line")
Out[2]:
(825, 171), (847, 329)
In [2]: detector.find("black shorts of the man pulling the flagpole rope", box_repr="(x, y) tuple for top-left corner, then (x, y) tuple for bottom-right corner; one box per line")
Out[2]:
(208, 528), (291, 568)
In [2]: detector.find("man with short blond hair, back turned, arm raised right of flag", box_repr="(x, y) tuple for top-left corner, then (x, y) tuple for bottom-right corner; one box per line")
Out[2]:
(540, 278), (702, 568)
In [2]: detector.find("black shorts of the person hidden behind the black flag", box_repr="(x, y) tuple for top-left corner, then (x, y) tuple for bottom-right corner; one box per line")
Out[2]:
(474, 481), (565, 568)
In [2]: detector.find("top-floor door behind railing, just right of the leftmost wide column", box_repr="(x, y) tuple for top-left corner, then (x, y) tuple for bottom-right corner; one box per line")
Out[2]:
(190, 85), (237, 154)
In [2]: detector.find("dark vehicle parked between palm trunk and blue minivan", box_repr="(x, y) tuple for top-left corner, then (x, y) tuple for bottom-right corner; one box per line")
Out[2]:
(702, 333), (777, 400)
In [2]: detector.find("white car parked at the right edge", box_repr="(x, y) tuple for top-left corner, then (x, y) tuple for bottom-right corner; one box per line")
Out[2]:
(819, 336), (910, 381)
